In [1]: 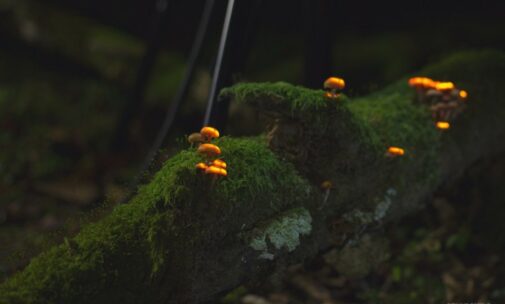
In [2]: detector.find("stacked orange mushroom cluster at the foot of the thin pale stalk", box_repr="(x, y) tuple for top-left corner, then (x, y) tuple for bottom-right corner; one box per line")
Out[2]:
(188, 127), (228, 177)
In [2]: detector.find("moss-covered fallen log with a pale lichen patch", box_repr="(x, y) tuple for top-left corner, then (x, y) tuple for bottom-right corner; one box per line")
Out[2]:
(0, 51), (505, 303)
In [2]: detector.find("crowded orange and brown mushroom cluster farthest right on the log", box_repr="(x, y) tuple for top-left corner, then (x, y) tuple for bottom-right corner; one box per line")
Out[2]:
(409, 77), (468, 130)
